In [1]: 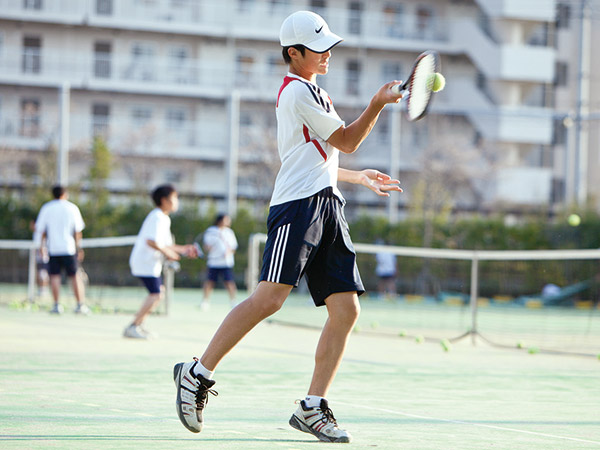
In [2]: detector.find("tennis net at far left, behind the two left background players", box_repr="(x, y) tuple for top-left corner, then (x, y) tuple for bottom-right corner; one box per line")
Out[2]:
(0, 236), (179, 314)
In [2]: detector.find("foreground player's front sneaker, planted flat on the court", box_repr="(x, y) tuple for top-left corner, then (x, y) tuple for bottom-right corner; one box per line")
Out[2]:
(290, 399), (352, 443)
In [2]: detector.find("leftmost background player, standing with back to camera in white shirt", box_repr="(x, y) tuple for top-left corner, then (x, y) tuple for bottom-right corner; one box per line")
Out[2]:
(34, 186), (89, 314)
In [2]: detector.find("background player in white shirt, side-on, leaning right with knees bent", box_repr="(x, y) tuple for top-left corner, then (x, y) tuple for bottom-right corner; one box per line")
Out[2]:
(123, 184), (197, 339)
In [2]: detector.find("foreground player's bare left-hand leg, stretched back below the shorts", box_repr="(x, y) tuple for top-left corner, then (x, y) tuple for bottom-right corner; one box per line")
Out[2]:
(200, 281), (292, 370)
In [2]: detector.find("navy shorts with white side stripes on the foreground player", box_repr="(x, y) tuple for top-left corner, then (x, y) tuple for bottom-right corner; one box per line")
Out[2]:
(260, 187), (365, 306)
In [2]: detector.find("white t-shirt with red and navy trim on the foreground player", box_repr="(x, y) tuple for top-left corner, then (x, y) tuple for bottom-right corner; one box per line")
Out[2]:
(271, 73), (344, 206)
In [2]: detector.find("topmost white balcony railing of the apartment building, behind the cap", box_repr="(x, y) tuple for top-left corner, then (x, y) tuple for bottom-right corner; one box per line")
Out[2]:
(0, 0), (448, 42)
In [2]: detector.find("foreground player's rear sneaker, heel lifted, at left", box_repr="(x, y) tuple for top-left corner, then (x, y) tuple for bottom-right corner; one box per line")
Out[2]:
(173, 358), (219, 433)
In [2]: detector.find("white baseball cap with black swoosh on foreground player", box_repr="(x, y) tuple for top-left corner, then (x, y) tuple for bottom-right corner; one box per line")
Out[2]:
(279, 11), (343, 53)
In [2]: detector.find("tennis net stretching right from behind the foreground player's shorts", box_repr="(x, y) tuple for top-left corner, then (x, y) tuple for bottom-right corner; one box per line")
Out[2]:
(247, 234), (600, 358)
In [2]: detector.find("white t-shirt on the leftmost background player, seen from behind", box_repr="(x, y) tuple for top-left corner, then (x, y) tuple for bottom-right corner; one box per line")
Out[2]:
(34, 199), (85, 256)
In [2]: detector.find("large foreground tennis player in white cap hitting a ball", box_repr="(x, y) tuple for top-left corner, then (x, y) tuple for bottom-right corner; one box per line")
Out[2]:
(174, 11), (401, 442)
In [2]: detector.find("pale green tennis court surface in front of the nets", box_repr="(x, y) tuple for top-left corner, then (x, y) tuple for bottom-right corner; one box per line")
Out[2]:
(0, 288), (600, 450)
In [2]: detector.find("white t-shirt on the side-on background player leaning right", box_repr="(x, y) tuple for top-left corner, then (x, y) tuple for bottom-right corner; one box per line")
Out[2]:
(129, 208), (173, 278)
